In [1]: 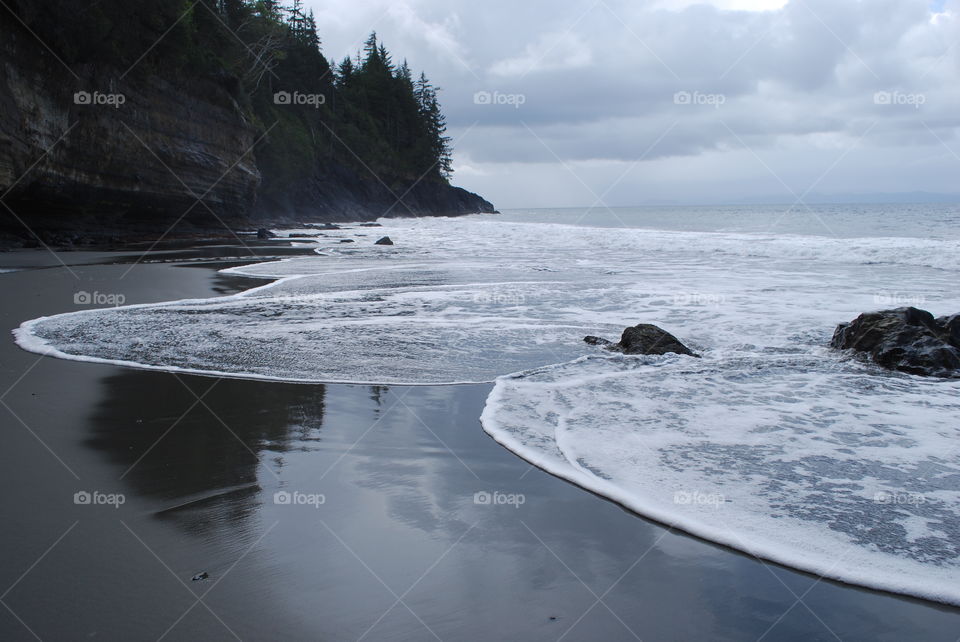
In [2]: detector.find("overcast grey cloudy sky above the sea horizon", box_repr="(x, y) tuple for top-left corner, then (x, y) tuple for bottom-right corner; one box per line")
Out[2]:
(306, 0), (960, 208)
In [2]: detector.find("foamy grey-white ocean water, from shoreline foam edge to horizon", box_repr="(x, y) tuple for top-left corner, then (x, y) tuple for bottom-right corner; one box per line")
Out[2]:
(16, 205), (960, 604)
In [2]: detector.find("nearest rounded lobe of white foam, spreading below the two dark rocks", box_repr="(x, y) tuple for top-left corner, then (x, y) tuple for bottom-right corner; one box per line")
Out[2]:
(481, 355), (960, 604)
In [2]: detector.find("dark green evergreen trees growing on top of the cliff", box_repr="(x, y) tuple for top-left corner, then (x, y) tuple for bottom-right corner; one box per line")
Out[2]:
(8, 0), (452, 202)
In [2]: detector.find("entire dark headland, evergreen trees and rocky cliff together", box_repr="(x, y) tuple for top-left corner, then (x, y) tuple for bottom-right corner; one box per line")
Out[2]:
(0, 0), (493, 242)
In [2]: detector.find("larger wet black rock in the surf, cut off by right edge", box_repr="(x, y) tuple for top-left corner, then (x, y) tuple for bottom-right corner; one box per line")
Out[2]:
(830, 308), (960, 377)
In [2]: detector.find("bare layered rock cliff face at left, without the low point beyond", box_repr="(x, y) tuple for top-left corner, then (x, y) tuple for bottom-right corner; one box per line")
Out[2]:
(0, 20), (260, 240)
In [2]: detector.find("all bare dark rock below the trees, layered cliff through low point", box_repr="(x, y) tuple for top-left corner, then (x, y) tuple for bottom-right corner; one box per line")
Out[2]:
(0, 20), (493, 242)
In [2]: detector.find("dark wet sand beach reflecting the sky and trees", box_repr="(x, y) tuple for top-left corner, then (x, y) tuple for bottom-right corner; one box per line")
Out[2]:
(0, 245), (960, 642)
